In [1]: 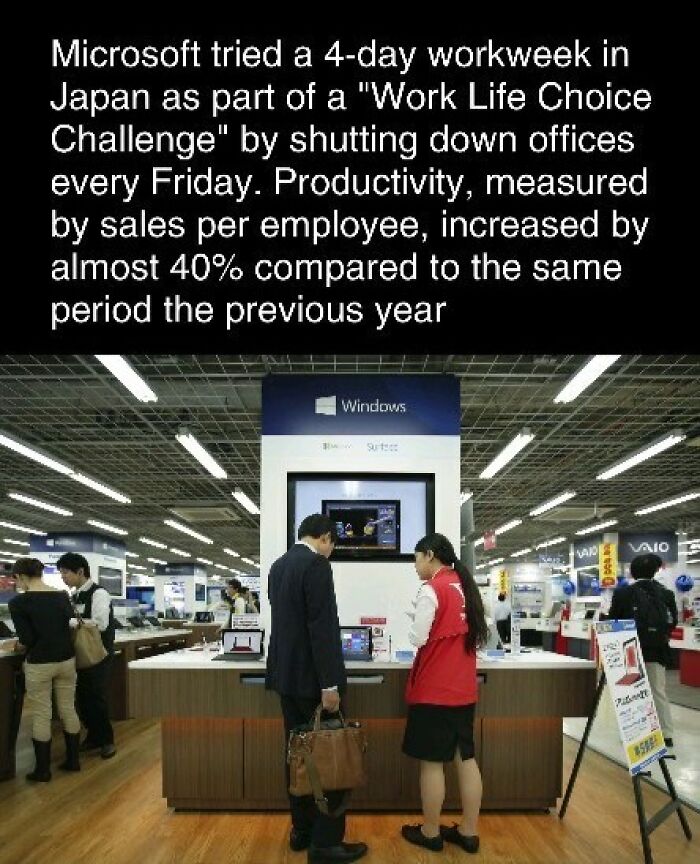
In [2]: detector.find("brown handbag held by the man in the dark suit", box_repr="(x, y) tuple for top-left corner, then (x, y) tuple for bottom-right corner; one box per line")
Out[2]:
(287, 705), (367, 816)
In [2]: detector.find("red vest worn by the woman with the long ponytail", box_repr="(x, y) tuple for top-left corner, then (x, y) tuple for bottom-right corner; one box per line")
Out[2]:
(406, 567), (479, 705)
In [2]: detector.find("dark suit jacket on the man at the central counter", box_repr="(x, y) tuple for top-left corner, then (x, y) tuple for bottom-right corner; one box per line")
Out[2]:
(266, 543), (347, 701)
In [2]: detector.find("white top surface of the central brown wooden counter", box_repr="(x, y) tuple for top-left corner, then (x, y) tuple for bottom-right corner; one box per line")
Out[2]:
(129, 648), (595, 675)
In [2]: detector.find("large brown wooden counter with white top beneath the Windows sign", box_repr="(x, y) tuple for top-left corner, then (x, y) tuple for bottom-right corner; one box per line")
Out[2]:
(129, 650), (596, 810)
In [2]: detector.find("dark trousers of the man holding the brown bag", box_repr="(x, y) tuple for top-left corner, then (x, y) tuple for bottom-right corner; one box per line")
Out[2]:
(280, 695), (345, 848)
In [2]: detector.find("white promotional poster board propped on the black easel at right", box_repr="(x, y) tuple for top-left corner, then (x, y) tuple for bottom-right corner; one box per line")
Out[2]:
(595, 621), (666, 774)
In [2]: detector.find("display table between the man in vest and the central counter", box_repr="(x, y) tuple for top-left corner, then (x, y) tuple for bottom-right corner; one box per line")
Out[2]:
(109, 627), (194, 720)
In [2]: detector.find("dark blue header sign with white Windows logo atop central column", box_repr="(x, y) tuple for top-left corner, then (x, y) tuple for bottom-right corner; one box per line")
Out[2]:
(262, 375), (460, 436)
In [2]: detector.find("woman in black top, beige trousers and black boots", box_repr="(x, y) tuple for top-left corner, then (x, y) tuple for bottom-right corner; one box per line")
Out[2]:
(8, 558), (80, 783)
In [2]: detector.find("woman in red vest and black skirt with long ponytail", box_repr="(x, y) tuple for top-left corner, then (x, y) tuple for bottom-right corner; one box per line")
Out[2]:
(401, 534), (488, 852)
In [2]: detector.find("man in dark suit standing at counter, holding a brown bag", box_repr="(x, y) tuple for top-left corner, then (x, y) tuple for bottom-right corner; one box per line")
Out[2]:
(266, 513), (367, 864)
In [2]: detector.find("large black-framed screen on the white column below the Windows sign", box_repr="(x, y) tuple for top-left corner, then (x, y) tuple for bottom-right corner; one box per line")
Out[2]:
(287, 474), (435, 561)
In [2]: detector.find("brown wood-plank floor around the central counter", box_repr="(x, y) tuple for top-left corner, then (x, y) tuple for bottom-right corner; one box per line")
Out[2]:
(0, 720), (700, 864)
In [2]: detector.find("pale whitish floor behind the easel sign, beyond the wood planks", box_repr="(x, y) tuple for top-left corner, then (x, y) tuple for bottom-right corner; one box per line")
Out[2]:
(564, 685), (700, 811)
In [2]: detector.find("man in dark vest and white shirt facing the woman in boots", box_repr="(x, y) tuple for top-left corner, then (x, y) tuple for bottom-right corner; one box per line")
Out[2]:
(56, 552), (117, 759)
